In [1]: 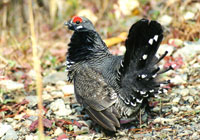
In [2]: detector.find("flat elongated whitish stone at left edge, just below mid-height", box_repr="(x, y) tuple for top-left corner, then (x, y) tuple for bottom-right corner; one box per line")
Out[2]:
(0, 80), (24, 91)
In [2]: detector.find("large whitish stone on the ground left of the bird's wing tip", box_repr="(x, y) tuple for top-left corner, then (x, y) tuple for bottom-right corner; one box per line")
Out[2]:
(50, 99), (72, 116)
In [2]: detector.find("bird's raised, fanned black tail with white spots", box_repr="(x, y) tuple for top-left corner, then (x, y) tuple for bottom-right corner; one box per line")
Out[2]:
(118, 19), (172, 106)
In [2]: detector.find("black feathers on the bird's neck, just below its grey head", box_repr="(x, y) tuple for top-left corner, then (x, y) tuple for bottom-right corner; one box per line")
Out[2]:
(67, 31), (110, 62)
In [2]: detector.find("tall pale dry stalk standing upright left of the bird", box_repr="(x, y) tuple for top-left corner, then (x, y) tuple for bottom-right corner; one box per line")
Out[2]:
(28, 0), (44, 140)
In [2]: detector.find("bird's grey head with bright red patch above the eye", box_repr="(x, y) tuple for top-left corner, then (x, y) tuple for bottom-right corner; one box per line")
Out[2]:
(64, 16), (95, 32)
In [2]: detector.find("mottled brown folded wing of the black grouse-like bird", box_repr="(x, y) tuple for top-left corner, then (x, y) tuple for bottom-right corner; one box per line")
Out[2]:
(74, 66), (120, 131)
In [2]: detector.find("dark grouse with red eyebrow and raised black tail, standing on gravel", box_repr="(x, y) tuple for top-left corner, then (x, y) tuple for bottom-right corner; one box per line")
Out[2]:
(64, 16), (173, 132)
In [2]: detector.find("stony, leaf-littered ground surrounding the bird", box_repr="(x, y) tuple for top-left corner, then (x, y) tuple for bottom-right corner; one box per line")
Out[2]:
(0, 0), (200, 140)
